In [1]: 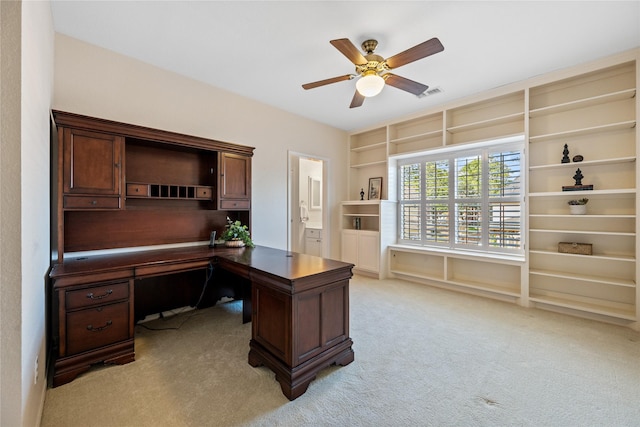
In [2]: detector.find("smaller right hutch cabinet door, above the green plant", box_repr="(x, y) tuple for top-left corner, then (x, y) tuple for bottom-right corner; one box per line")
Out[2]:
(218, 153), (251, 210)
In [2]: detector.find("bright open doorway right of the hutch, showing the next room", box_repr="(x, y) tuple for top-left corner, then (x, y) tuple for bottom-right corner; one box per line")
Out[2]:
(287, 151), (330, 257)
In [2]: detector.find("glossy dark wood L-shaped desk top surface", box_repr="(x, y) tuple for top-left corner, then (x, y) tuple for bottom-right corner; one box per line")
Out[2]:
(49, 245), (353, 292)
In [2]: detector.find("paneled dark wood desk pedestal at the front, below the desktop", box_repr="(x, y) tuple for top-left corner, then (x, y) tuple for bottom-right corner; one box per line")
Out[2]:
(249, 266), (354, 400)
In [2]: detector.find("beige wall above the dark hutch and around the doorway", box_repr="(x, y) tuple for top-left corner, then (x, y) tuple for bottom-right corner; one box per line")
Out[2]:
(53, 34), (347, 258)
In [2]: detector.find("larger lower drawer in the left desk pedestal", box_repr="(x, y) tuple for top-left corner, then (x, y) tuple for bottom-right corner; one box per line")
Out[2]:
(66, 301), (129, 356)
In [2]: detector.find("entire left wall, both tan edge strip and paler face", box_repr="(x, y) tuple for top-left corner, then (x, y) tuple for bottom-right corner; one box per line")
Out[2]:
(0, 1), (53, 426)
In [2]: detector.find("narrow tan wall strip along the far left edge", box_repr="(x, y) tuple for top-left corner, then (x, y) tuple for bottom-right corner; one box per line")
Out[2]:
(0, 1), (22, 426)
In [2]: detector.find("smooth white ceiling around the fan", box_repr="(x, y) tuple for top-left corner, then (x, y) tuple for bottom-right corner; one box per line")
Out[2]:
(52, 0), (640, 130)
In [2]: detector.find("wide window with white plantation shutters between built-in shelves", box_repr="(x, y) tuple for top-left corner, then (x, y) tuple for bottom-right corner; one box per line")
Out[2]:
(398, 137), (524, 254)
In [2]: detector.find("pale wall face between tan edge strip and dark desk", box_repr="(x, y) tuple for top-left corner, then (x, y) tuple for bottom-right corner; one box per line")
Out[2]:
(20, 1), (54, 426)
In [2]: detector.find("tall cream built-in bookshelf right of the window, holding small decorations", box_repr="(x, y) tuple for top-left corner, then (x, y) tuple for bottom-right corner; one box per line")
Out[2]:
(528, 61), (638, 320)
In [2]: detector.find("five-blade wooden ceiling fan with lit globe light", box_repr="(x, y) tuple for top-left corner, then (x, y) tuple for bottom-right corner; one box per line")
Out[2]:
(302, 37), (444, 108)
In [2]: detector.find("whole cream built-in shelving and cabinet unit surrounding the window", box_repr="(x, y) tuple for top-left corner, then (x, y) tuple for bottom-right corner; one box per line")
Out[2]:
(348, 49), (640, 329)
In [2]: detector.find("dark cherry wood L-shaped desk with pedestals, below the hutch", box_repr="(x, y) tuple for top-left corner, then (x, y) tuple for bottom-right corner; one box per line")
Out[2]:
(50, 246), (354, 400)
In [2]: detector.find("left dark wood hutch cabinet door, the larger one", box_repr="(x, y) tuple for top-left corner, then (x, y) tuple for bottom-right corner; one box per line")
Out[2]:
(62, 128), (124, 195)
